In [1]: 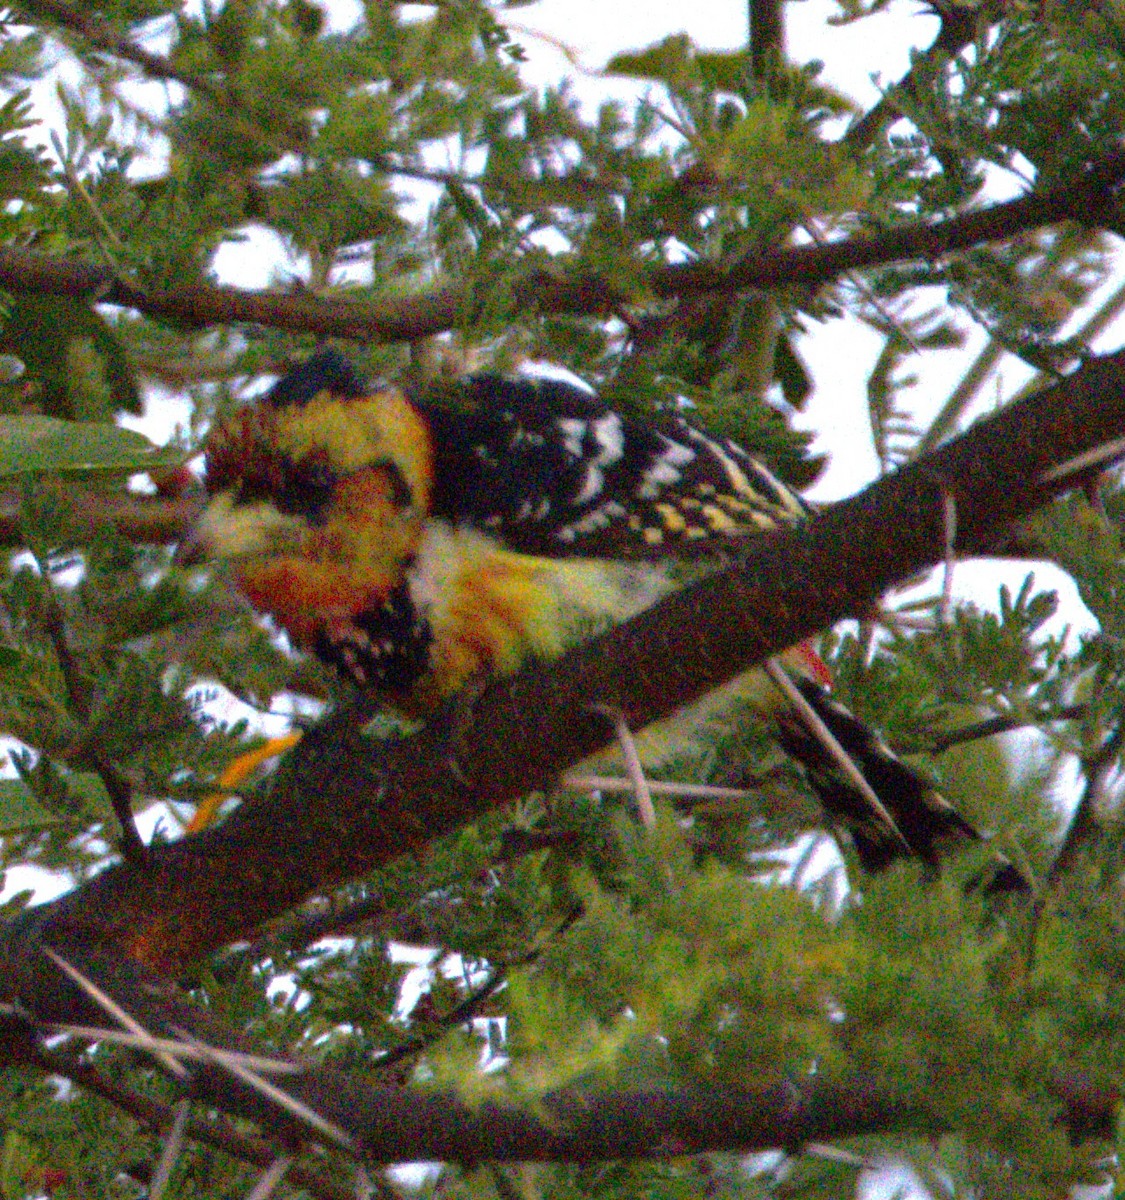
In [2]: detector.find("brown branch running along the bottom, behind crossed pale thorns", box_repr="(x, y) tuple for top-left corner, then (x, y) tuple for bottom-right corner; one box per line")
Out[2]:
(6, 944), (941, 1163)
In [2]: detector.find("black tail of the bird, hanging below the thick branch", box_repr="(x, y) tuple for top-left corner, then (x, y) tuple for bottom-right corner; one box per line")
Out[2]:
(774, 676), (1030, 894)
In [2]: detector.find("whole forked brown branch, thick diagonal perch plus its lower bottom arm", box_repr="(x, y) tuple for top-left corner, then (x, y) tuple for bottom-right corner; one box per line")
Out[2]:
(0, 353), (1125, 1162)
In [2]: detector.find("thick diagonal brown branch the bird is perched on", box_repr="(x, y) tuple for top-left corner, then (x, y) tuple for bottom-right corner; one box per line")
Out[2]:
(0, 353), (1125, 971)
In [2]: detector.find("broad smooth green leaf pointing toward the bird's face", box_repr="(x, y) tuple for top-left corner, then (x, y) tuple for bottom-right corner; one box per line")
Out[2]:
(0, 414), (184, 478)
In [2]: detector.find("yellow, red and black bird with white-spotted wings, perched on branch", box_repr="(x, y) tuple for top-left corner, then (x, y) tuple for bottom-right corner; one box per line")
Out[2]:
(176, 348), (1025, 890)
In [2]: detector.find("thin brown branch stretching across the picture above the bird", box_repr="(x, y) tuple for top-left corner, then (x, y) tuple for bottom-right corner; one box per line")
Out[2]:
(0, 151), (1125, 342)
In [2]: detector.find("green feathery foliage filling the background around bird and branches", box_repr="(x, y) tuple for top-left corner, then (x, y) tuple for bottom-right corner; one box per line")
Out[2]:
(0, 0), (1125, 1200)
